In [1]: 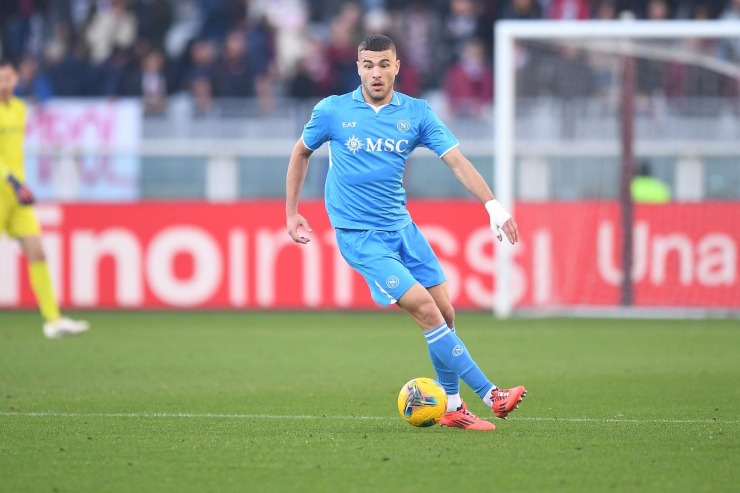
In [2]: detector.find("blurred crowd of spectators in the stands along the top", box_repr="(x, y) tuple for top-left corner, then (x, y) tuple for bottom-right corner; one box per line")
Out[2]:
(0, 0), (740, 115)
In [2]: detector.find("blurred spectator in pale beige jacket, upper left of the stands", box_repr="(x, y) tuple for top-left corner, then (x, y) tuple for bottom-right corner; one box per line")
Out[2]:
(87, 0), (136, 63)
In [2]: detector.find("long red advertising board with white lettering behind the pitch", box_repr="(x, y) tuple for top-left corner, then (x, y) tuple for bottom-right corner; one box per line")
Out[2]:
(0, 200), (740, 309)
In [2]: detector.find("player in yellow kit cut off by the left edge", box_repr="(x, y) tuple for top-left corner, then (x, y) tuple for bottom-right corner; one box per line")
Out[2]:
(0, 55), (88, 339)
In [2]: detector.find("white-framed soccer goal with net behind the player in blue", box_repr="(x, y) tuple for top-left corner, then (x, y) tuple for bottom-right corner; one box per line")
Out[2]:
(494, 21), (740, 317)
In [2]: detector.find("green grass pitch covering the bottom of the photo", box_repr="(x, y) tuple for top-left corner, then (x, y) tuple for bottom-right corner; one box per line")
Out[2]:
(0, 312), (740, 493)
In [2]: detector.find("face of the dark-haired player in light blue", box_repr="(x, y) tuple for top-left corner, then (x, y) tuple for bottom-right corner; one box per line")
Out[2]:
(357, 50), (401, 106)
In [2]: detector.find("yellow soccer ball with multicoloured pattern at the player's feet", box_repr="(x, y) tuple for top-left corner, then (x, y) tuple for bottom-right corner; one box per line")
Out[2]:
(398, 377), (447, 427)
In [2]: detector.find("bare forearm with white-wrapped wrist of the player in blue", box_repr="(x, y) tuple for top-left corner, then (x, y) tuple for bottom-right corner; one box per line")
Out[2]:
(442, 147), (519, 245)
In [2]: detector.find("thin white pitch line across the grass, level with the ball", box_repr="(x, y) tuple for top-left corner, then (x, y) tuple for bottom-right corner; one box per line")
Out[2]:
(0, 411), (740, 424)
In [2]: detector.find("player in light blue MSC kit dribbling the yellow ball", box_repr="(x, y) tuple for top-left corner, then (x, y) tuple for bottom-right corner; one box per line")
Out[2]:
(285, 34), (526, 430)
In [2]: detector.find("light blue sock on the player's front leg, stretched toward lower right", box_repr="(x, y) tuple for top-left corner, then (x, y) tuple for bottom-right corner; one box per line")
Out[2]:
(424, 323), (493, 399)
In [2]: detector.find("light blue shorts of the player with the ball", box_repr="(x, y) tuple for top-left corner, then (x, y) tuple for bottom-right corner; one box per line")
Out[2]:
(336, 223), (445, 306)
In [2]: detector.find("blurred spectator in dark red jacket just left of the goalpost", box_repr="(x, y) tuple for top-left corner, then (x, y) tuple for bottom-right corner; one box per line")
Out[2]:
(443, 39), (493, 118)
